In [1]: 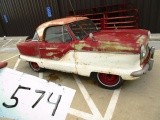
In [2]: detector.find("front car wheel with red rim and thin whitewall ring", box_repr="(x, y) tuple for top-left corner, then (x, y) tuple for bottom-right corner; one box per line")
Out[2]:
(96, 73), (124, 90)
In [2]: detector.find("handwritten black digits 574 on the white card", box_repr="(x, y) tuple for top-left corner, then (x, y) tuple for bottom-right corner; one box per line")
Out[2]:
(2, 85), (62, 116)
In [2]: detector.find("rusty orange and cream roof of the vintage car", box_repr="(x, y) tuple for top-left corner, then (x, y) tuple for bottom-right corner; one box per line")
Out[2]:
(37, 16), (88, 40)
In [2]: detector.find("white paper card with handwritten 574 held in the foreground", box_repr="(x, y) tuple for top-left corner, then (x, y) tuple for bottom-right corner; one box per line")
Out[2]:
(0, 68), (75, 120)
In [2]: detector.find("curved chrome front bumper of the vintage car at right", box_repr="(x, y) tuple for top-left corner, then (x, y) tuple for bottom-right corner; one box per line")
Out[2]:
(131, 47), (155, 77)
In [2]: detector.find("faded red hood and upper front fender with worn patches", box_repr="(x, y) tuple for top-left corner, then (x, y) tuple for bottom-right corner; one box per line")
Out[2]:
(85, 30), (149, 53)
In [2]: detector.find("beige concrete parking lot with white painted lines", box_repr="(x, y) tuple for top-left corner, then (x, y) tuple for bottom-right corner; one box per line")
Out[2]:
(0, 37), (160, 120)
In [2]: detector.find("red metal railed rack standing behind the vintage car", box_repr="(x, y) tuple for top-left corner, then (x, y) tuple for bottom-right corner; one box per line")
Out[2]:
(69, 0), (139, 30)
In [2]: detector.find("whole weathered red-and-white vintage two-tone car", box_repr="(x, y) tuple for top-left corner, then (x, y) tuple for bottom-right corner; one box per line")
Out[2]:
(17, 16), (155, 89)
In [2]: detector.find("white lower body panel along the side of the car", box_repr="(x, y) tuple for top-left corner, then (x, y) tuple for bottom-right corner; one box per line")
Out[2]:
(20, 51), (142, 80)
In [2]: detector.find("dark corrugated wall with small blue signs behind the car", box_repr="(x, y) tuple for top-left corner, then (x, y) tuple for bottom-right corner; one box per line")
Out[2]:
(0, 0), (160, 36)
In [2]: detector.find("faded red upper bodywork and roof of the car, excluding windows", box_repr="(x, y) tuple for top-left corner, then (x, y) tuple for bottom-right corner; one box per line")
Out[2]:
(17, 17), (149, 60)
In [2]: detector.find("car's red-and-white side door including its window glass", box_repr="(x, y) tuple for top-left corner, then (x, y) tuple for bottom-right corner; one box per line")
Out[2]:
(39, 25), (76, 73)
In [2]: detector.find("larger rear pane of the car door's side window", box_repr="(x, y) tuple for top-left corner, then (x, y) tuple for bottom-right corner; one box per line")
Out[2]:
(45, 26), (63, 42)
